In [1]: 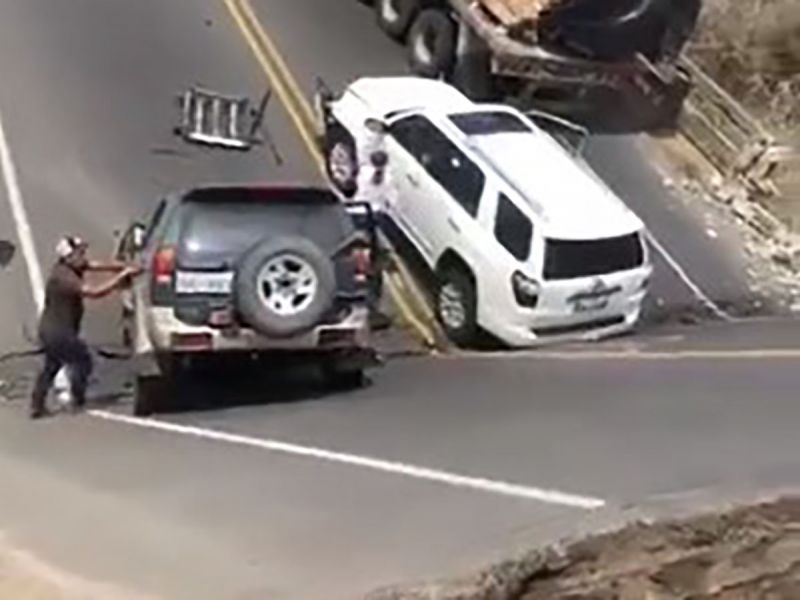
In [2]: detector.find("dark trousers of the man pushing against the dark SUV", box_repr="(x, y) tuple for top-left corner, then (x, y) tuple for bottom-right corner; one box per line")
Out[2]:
(31, 335), (92, 412)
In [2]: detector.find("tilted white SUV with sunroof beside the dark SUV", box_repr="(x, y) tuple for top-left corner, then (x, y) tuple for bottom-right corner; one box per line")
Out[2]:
(320, 77), (651, 346)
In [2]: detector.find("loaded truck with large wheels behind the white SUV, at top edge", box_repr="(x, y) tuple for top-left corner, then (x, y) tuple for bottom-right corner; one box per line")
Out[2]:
(372, 0), (701, 125)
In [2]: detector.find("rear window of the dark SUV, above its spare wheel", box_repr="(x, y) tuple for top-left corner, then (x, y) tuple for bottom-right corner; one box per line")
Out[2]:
(178, 197), (354, 269)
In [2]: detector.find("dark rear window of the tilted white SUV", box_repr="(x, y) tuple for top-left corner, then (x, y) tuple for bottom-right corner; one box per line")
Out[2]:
(544, 233), (644, 279)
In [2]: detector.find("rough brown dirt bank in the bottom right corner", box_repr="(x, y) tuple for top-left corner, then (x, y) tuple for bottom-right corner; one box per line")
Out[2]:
(369, 498), (800, 600)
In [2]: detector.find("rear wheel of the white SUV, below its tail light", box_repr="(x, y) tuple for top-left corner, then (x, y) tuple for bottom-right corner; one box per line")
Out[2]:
(436, 269), (480, 347)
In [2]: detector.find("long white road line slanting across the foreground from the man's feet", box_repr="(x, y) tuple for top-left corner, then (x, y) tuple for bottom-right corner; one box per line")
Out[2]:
(89, 410), (606, 510)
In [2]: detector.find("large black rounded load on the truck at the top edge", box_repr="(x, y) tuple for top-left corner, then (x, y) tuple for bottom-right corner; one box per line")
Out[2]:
(539, 0), (701, 60)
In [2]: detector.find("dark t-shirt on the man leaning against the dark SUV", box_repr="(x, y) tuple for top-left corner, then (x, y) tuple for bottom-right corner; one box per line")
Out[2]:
(39, 263), (83, 337)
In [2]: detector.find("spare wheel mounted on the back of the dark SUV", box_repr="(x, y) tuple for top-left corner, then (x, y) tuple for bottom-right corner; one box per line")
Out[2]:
(234, 236), (336, 338)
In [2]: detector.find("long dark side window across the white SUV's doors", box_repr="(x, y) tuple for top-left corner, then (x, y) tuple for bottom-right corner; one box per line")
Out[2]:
(390, 115), (486, 217)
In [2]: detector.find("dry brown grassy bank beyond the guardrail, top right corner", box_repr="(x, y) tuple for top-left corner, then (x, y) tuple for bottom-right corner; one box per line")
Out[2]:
(689, 0), (800, 140)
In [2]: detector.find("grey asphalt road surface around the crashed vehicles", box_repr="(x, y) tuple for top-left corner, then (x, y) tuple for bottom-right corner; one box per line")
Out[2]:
(0, 0), (800, 600)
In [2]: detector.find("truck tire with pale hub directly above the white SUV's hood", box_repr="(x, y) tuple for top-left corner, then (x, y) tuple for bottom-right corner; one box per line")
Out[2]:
(407, 8), (457, 79)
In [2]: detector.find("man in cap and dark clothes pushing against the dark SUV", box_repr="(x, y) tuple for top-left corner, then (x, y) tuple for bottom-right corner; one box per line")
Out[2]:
(30, 237), (141, 419)
